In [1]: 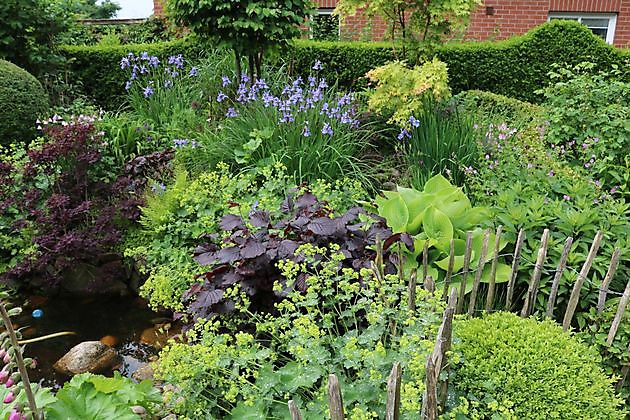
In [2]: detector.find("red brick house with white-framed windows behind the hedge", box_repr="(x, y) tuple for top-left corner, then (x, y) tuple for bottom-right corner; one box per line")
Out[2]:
(153, 0), (630, 47)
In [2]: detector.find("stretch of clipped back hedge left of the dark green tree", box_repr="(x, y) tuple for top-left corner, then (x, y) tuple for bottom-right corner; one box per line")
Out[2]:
(59, 38), (206, 110)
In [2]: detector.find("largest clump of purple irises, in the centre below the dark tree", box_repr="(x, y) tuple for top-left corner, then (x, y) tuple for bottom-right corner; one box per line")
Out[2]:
(187, 62), (378, 184)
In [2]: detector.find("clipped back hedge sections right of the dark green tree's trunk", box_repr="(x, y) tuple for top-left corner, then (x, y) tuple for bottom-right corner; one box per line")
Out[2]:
(285, 20), (630, 102)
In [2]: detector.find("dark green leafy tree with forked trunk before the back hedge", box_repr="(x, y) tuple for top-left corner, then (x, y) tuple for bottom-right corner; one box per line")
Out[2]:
(167, 0), (312, 78)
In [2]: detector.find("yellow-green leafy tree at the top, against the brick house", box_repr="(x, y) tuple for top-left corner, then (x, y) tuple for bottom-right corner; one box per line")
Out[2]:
(335, 0), (482, 55)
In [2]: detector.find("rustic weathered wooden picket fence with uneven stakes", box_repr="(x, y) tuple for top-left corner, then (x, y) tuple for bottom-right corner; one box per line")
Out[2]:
(288, 227), (630, 420)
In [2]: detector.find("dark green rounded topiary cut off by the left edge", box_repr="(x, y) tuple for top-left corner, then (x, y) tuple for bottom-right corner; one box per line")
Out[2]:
(0, 60), (48, 145)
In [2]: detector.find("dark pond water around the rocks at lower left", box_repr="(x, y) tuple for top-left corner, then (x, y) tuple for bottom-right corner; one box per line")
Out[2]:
(14, 296), (169, 388)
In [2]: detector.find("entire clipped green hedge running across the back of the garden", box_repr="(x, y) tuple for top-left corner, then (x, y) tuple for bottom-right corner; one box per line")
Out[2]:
(61, 20), (630, 109)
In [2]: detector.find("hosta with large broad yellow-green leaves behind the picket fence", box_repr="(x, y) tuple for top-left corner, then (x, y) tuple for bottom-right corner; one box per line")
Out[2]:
(376, 175), (510, 290)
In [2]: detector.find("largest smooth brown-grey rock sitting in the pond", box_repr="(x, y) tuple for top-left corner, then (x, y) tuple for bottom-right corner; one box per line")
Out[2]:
(53, 341), (120, 376)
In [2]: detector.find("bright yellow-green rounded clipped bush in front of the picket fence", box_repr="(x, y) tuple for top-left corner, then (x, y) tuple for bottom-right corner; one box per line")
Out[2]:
(449, 313), (624, 419)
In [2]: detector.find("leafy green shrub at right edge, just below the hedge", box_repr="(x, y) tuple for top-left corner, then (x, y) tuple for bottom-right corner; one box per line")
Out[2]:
(544, 63), (630, 196)
